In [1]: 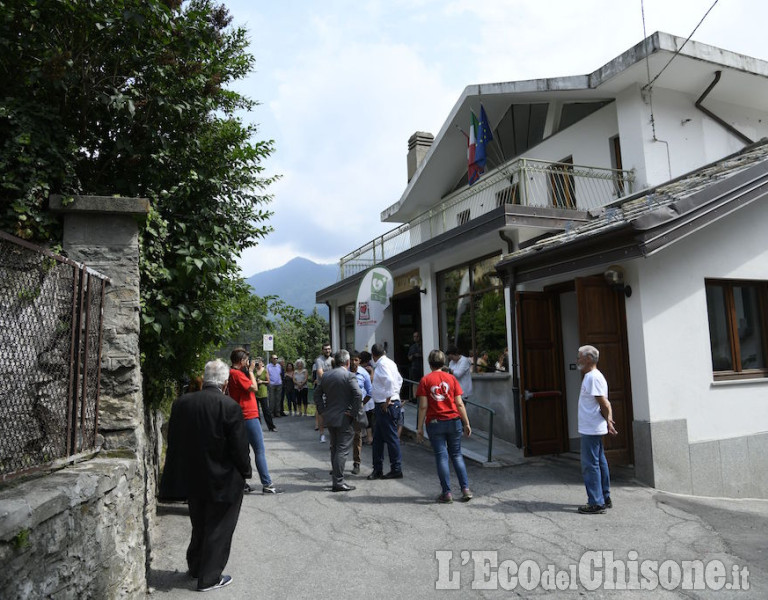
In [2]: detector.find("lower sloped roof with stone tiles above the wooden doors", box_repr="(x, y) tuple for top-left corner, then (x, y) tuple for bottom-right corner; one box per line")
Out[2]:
(496, 139), (768, 282)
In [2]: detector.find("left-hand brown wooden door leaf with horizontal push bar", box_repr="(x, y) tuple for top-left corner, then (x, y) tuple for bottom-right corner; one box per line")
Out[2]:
(516, 292), (568, 456)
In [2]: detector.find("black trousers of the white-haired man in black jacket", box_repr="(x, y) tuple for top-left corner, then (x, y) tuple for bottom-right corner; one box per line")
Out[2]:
(187, 488), (243, 589)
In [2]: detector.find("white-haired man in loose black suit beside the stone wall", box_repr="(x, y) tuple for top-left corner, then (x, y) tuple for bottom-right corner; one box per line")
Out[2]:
(160, 360), (251, 591)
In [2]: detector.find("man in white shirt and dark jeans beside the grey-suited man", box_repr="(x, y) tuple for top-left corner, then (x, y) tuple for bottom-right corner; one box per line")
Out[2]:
(368, 344), (403, 479)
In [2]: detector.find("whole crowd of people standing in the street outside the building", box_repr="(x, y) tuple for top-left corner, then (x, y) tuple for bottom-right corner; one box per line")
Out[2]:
(159, 344), (616, 591)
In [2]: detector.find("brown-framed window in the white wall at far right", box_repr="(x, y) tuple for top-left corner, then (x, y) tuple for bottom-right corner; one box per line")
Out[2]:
(706, 279), (768, 379)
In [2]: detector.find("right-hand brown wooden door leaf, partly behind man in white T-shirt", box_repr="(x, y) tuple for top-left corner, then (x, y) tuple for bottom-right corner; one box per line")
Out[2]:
(576, 275), (634, 465)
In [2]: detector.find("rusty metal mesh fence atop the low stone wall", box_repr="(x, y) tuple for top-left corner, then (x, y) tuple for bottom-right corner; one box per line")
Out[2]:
(0, 232), (108, 481)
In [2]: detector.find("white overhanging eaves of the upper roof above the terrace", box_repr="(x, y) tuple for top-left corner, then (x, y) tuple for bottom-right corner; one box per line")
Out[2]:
(388, 31), (768, 223)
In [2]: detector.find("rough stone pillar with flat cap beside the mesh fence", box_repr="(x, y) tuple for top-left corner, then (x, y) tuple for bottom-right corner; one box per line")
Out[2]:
(50, 196), (149, 455)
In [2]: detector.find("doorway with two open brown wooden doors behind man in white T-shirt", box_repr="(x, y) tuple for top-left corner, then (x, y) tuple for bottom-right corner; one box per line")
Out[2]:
(516, 275), (634, 465)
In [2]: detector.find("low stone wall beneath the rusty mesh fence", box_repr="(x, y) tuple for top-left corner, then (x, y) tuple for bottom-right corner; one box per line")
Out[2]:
(0, 458), (146, 600)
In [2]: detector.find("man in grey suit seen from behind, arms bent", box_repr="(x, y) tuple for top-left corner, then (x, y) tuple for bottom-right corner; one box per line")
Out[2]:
(314, 350), (363, 492)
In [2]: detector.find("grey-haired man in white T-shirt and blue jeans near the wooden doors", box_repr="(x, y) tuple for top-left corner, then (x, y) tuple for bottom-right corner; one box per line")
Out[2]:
(576, 346), (617, 514)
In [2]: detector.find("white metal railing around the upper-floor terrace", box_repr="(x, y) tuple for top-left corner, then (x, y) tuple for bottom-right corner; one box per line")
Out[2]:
(339, 158), (634, 281)
